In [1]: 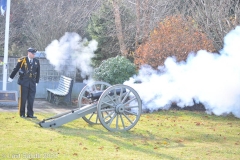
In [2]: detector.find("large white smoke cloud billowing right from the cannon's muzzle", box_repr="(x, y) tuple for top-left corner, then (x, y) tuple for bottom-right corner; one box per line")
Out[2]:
(124, 26), (240, 118)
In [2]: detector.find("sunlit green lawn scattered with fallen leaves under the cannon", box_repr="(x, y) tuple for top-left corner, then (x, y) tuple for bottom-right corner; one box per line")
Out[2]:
(0, 110), (240, 160)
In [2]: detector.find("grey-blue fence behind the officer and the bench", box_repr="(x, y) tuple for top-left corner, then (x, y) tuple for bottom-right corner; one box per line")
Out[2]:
(0, 52), (85, 98)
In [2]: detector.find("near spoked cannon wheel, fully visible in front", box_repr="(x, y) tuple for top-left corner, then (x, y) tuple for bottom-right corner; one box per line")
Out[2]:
(97, 84), (142, 131)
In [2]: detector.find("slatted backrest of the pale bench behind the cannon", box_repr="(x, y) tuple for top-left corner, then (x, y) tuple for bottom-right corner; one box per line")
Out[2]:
(57, 76), (73, 94)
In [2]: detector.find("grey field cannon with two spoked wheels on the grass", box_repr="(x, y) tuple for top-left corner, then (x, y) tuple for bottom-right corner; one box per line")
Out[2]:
(39, 81), (142, 132)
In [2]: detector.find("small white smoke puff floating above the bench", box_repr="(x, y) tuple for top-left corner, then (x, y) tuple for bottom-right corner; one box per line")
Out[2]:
(45, 32), (98, 78)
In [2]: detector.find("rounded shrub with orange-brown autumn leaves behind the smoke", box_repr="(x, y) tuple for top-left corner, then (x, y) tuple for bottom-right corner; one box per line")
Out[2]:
(134, 16), (215, 68)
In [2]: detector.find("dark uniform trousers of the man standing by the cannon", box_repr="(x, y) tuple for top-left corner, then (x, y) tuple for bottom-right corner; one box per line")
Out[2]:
(19, 85), (36, 116)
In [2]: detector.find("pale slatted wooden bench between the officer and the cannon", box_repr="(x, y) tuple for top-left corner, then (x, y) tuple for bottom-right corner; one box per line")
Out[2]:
(46, 76), (73, 105)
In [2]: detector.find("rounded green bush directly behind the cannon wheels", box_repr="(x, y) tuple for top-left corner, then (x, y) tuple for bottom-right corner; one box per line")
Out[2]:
(93, 56), (136, 85)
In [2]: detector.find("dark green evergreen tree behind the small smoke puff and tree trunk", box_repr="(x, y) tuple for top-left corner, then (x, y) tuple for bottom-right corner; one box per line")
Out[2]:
(87, 2), (134, 67)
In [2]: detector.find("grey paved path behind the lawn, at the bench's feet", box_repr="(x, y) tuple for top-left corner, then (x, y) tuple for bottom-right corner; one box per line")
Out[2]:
(0, 99), (77, 114)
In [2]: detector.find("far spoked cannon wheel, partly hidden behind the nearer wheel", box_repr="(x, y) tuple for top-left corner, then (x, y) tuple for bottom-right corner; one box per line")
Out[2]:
(78, 81), (111, 124)
